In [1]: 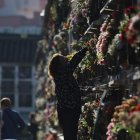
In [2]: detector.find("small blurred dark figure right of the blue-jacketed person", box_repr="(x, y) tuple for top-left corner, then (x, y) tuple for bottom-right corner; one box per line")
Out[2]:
(28, 112), (38, 140)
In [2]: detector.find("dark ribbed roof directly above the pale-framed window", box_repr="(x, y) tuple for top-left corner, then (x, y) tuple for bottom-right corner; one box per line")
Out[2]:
(0, 34), (41, 64)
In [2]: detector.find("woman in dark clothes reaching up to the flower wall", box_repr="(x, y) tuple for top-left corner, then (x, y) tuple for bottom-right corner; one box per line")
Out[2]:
(49, 47), (88, 140)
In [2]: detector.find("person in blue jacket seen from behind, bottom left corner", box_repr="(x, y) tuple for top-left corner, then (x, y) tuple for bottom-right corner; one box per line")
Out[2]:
(0, 98), (25, 140)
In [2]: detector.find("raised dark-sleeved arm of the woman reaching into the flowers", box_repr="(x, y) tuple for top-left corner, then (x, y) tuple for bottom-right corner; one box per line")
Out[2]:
(68, 47), (88, 73)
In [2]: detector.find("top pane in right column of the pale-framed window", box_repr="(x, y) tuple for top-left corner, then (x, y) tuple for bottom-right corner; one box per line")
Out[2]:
(18, 66), (32, 79)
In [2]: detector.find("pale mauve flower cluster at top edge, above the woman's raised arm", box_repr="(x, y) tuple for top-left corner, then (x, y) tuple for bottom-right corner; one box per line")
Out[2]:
(63, 0), (89, 40)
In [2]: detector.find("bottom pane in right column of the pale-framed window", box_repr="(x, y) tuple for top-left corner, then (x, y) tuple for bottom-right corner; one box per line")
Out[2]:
(19, 94), (32, 107)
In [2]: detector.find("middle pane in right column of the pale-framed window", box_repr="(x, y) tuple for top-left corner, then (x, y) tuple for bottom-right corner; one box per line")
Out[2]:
(18, 81), (32, 94)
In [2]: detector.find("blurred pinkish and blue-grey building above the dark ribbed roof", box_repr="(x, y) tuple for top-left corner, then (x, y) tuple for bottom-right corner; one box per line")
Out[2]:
(0, 0), (46, 34)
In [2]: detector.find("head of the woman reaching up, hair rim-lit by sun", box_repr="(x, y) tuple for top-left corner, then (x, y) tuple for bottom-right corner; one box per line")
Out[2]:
(49, 54), (68, 77)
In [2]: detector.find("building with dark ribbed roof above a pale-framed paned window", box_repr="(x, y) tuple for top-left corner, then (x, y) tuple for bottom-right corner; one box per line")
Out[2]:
(0, 34), (40, 120)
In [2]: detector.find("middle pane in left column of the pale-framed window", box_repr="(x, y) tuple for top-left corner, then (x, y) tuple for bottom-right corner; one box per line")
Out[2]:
(1, 81), (15, 93)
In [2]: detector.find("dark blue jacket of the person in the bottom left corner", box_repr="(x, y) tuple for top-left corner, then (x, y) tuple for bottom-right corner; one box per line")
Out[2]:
(1, 108), (25, 139)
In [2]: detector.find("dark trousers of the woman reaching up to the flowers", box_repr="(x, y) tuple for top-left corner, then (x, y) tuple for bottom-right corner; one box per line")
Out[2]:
(58, 110), (80, 140)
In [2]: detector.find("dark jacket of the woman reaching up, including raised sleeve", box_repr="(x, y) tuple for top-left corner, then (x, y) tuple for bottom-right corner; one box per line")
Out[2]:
(54, 48), (87, 112)
